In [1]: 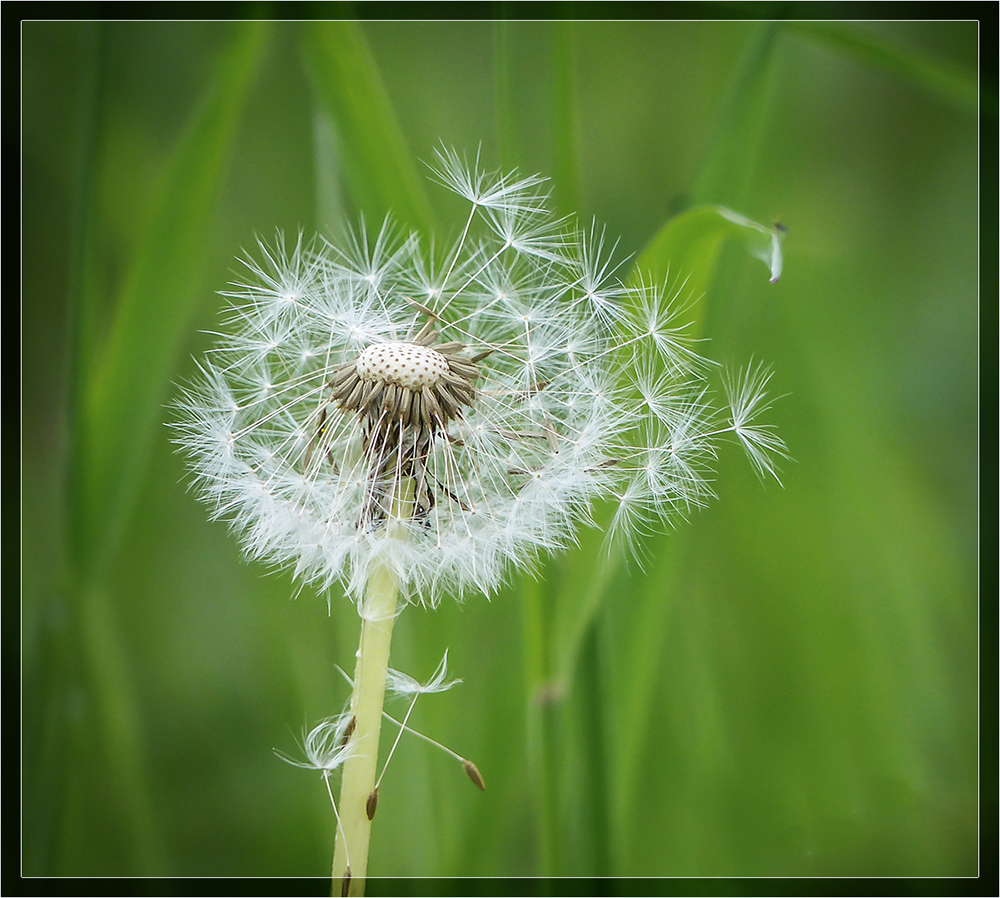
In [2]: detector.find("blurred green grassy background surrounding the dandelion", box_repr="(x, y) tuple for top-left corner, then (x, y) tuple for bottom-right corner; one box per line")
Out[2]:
(21, 8), (984, 887)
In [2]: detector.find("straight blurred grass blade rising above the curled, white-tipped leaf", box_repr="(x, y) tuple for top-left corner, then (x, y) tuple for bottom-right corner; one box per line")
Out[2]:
(691, 22), (780, 206)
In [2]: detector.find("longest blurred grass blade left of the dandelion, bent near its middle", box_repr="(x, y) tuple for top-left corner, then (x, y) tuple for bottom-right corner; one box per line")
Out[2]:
(64, 22), (266, 874)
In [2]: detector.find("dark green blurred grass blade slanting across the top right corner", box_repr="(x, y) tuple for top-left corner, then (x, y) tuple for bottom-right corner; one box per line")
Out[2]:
(788, 21), (984, 116)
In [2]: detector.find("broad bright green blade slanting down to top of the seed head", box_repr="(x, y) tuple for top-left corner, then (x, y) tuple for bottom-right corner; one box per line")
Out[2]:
(302, 21), (434, 236)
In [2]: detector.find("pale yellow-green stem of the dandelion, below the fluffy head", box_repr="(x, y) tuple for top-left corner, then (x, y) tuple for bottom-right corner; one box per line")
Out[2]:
(333, 478), (413, 895)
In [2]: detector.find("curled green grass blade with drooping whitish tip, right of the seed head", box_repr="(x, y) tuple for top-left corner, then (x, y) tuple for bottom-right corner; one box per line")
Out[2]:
(631, 206), (784, 335)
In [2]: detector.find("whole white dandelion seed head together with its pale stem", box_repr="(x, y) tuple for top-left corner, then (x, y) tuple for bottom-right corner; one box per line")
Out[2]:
(177, 151), (784, 888)
